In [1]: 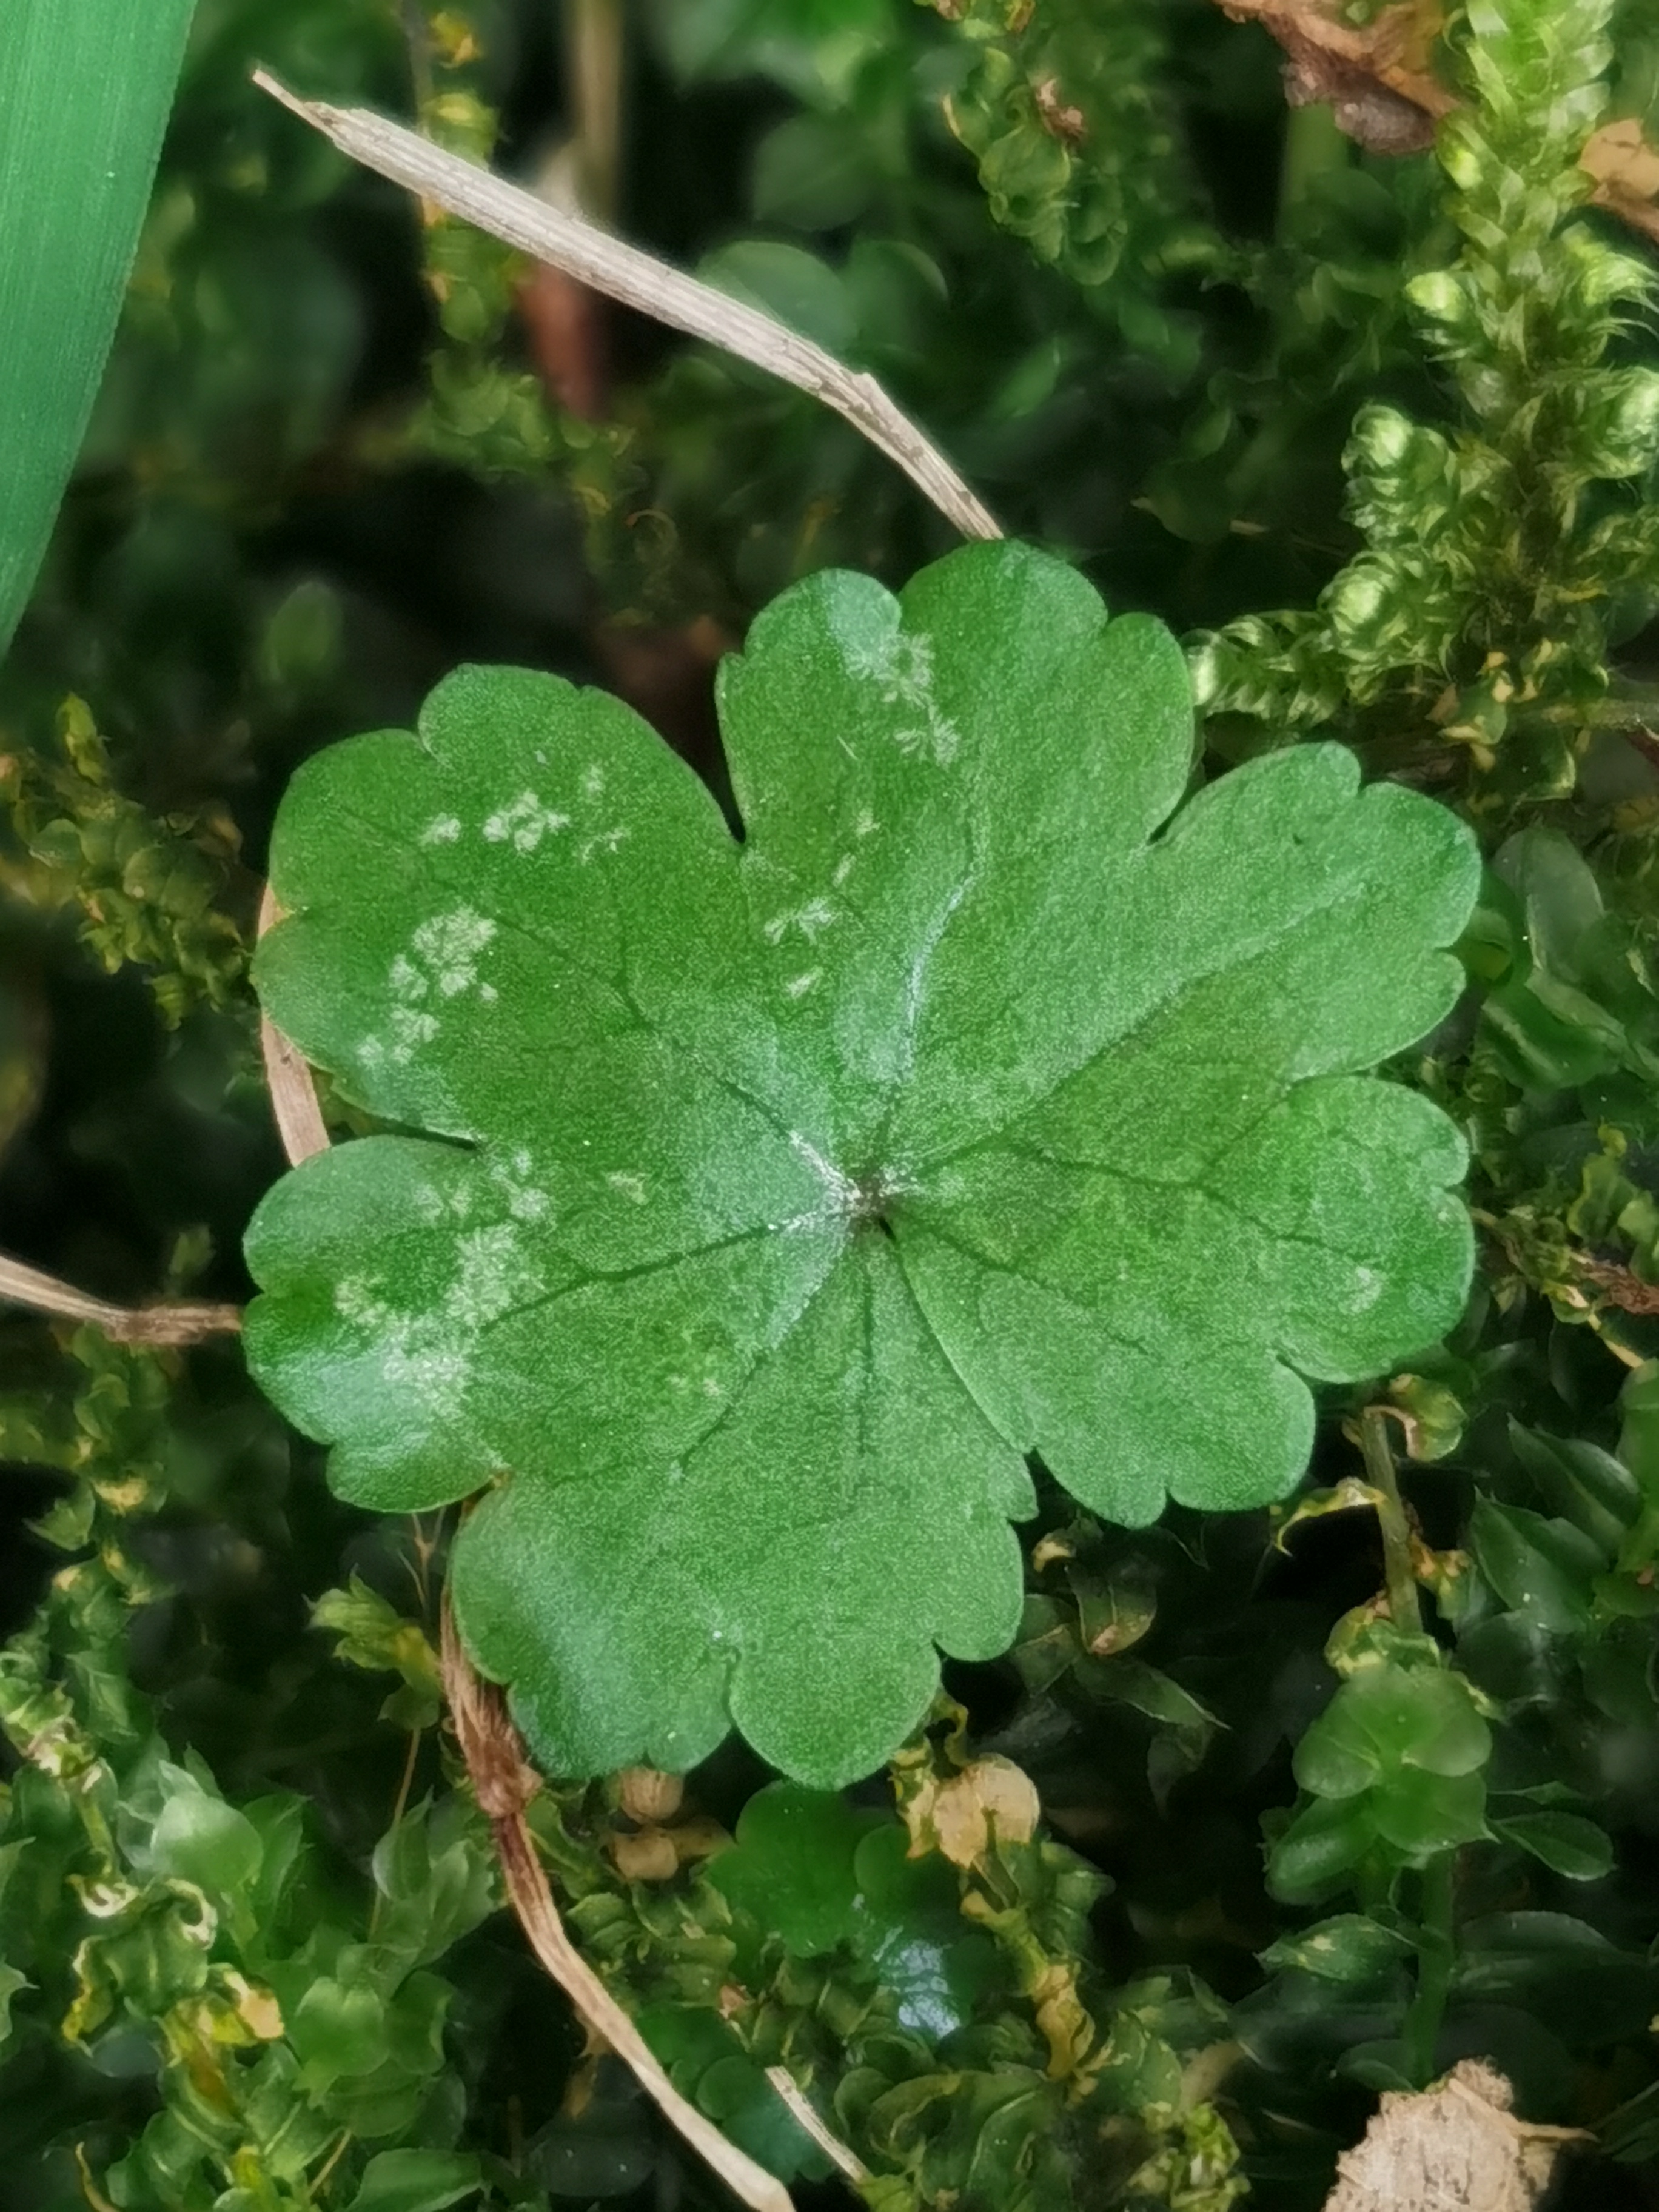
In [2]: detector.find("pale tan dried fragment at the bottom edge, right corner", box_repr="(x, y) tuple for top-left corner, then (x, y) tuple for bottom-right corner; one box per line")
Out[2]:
(1325, 2059), (1584, 2212)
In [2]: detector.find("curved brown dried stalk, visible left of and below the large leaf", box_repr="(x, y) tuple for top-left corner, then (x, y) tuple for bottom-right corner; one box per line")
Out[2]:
(259, 885), (805, 2212)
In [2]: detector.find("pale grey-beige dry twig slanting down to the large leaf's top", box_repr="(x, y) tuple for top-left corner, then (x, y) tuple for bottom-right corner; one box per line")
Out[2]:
(255, 69), (1002, 537)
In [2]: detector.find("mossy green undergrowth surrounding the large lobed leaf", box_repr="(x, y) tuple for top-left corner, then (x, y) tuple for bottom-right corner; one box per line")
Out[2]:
(0, 0), (1659, 2212)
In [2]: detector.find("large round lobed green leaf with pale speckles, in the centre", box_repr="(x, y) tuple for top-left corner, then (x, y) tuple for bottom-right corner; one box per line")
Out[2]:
(246, 544), (1475, 1785)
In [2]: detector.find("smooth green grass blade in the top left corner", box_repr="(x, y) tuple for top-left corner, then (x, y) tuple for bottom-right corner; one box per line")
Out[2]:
(0, 0), (195, 652)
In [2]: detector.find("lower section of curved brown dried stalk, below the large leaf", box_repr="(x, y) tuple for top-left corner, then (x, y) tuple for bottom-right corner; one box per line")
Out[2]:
(443, 1597), (794, 2212)
